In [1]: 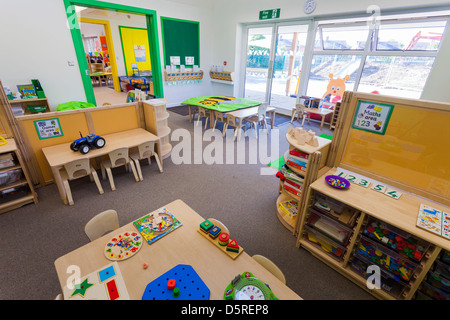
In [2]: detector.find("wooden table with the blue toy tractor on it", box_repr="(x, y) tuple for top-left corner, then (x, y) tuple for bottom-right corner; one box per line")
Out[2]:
(42, 128), (159, 204)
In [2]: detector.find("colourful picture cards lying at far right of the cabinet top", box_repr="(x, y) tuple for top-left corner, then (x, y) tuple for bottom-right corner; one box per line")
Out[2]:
(417, 203), (450, 239)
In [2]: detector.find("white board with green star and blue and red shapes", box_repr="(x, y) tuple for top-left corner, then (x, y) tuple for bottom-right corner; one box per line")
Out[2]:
(63, 262), (130, 300)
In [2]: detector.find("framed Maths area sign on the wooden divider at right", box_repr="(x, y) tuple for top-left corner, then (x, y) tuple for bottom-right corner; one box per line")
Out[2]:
(352, 101), (394, 135)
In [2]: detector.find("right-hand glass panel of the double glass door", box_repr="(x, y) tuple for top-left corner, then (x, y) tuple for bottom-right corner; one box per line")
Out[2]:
(269, 25), (308, 111)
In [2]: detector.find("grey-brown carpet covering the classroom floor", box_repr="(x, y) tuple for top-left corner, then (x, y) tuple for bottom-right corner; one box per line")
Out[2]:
(0, 113), (373, 300)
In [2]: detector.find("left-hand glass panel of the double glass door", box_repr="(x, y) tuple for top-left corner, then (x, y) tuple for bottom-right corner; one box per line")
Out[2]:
(244, 27), (273, 102)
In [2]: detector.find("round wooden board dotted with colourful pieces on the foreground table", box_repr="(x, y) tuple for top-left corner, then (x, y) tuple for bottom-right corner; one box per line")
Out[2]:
(103, 231), (143, 261)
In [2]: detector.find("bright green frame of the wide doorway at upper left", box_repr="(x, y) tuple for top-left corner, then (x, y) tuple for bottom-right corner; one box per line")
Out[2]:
(64, 0), (164, 105)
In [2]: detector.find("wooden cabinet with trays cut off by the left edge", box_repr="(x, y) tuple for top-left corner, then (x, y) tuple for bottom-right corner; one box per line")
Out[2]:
(0, 139), (37, 213)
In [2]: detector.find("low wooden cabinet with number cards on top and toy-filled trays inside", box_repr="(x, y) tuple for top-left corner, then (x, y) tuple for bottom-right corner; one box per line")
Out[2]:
(297, 169), (450, 300)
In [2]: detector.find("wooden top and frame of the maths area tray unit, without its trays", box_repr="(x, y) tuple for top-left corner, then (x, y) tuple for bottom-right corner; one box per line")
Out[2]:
(297, 168), (450, 300)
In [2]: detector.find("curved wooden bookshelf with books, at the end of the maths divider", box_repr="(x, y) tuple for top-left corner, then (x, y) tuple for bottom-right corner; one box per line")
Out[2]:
(276, 133), (331, 235)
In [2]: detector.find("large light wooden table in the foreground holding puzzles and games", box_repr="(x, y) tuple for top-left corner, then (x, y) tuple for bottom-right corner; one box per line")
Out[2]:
(55, 200), (301, 300)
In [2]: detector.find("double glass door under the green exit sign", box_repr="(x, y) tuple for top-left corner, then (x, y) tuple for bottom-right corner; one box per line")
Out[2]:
(244, 21), (312, 114)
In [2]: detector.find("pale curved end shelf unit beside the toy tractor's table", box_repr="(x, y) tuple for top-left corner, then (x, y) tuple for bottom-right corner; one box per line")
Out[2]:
(142, 99), (172, 160)
